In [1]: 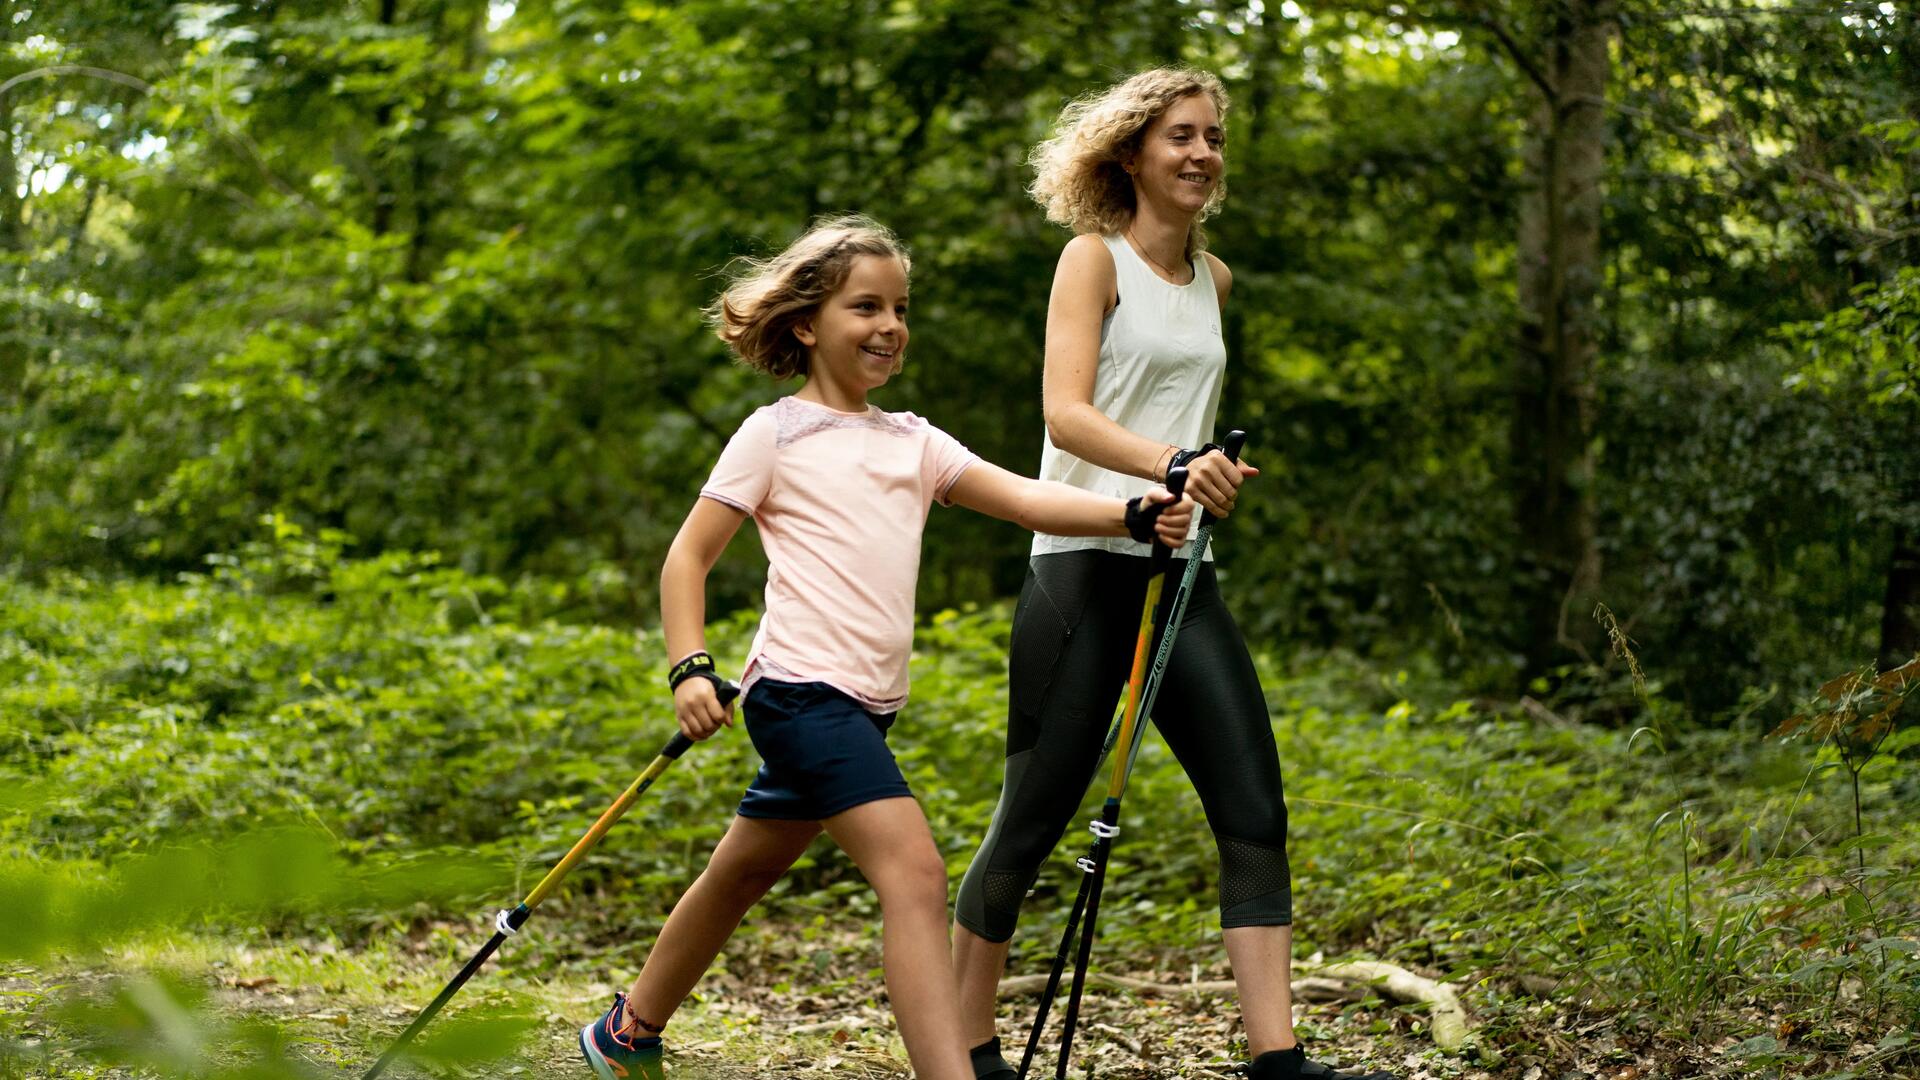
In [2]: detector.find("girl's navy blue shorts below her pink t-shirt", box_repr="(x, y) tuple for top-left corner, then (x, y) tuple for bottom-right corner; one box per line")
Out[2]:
(739, 678), (914, 821)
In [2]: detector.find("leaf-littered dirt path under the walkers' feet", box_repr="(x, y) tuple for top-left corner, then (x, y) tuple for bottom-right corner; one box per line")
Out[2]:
(0, 914), (1451, 1080)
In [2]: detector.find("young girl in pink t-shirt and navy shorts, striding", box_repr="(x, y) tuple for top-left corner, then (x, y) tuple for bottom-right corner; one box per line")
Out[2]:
(580, 217), (1192, 1080)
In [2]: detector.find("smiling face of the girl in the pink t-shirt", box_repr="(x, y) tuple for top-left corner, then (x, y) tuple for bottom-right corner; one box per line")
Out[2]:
(793, 256), (906, 405)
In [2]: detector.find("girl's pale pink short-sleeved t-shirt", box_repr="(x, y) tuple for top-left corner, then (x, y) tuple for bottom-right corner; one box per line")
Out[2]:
(701, 390), (979, 713)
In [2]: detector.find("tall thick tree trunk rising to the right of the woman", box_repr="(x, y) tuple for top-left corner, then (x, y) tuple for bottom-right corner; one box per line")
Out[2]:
(1509, 0), (1613, 676)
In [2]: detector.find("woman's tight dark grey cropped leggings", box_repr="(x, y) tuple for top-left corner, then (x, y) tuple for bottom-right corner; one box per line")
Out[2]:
(954, 552), (1292, 942)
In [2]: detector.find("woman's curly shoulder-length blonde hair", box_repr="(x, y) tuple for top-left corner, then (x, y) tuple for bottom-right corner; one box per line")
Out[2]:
(1027, 67), (1227, 259)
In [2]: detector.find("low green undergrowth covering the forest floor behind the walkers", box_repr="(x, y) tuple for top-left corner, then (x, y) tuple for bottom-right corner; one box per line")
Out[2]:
(0, 545), (1920, 1061)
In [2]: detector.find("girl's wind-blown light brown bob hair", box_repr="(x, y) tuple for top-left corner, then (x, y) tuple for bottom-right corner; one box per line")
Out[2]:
(707, 213), (914, 379)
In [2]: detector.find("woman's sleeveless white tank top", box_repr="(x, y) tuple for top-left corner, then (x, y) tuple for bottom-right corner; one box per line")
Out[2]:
(1033, 236), (1227, 559)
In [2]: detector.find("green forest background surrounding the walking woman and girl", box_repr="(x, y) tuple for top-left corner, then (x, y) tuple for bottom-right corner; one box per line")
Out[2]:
(0, 0), (1920, 1074)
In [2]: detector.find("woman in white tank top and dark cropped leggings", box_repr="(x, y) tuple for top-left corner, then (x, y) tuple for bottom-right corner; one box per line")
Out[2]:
(954, 69), (1392, 1080)
